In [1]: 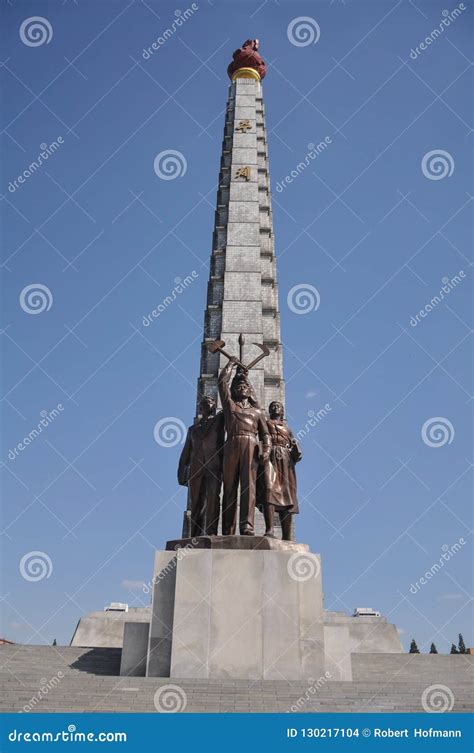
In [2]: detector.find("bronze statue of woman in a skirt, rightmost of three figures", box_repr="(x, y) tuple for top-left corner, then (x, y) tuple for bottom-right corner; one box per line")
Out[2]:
(259, 400), (303, 541)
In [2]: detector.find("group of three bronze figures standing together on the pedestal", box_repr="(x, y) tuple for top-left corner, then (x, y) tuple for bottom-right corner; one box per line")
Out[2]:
(178, 357), (302, 541)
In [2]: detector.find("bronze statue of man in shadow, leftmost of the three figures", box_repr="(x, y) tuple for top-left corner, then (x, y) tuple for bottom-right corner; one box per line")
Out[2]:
(178, 396), (224, 536)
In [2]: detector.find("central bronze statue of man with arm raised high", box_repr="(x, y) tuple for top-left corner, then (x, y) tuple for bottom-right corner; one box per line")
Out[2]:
(218, 357), (270, 536)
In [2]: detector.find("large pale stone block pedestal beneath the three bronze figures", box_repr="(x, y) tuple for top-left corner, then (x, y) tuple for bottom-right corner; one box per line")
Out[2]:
(146, 536), (330, 680)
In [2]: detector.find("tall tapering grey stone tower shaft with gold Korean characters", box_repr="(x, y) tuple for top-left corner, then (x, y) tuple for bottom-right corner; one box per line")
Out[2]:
(183, 40), (285, 536)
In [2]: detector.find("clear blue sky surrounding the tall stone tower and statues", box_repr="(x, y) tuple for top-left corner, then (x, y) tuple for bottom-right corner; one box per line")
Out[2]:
(0, 0), (472, 651)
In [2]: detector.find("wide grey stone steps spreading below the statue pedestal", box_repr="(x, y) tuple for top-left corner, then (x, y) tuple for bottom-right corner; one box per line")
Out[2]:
(0, 645), (474, 713)
